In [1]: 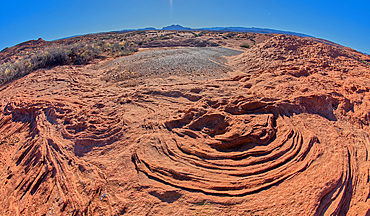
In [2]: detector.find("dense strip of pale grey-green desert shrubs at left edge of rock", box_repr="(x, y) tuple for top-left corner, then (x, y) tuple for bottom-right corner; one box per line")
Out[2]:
(0, 40), (137, 85)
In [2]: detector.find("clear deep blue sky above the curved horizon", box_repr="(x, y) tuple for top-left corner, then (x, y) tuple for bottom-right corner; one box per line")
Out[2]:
(0, 0), (370, 54)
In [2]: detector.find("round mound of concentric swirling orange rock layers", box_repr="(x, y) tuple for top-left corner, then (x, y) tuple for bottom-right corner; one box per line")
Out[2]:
(133, 100), (318, 196)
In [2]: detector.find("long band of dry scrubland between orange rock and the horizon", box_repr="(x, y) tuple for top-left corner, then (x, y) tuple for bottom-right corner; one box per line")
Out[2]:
(0, 30), (271, 85)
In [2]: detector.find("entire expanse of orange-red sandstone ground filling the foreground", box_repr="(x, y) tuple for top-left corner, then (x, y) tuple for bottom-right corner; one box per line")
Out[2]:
(0, 35), (370, 215)
